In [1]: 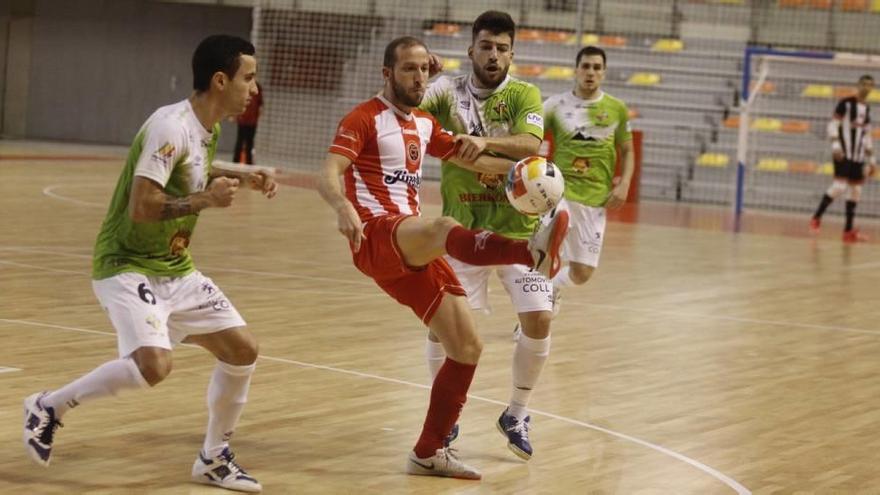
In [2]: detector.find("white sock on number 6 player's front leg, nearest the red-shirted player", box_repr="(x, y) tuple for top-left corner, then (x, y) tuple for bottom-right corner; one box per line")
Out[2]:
(203, 361), (257, 458)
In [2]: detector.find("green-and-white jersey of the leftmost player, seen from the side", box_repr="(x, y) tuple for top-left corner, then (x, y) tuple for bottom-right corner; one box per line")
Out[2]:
(92, 100), (220, 280)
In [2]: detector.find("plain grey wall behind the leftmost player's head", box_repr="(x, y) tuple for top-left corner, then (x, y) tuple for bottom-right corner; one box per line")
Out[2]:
(17, 0), (251, 149)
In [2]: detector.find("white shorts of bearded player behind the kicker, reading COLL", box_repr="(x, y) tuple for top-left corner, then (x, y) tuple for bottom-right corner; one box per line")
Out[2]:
(446, 256), (553, 313)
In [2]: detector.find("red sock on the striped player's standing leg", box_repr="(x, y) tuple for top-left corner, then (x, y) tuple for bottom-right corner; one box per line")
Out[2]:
(413, 357), (477, 459)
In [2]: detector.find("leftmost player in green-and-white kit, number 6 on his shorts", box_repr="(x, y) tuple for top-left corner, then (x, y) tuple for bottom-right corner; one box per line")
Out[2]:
(24, 35), (277, 492)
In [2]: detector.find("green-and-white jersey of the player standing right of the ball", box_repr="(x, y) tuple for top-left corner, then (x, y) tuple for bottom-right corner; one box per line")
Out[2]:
(544, 91), (632, 206)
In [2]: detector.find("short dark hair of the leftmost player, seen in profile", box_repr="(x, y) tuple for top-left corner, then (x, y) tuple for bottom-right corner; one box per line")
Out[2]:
(192, 34), (256, 92)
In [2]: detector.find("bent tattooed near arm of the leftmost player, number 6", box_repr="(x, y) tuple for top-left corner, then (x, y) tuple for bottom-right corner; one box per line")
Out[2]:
(128, 176), (238, 222)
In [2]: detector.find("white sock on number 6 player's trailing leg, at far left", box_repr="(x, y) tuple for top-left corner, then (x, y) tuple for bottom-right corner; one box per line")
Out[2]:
(40, 357), (150, 418)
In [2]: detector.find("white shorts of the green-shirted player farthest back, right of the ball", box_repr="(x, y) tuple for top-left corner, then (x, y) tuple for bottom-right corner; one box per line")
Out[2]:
(558, 200), (605, 268)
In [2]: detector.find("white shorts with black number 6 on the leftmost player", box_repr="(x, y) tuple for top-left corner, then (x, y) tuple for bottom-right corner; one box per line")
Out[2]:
(92, 271), (245, 357)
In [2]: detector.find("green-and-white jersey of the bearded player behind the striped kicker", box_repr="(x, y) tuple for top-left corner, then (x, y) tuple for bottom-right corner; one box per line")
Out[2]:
(421, 74), (544, 239)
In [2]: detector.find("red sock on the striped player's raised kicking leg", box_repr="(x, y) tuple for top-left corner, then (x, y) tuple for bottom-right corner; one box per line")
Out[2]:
(446, 225), (535, 266)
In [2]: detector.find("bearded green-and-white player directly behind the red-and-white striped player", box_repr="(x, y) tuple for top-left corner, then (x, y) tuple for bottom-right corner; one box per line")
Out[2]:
(421, 11), (561, 459)
